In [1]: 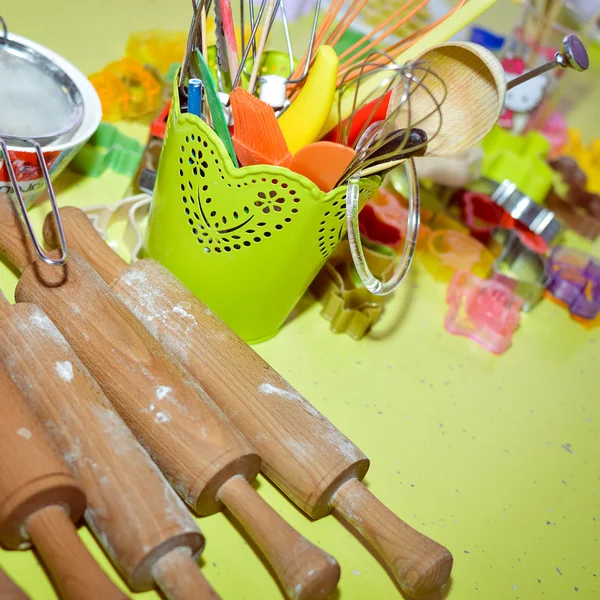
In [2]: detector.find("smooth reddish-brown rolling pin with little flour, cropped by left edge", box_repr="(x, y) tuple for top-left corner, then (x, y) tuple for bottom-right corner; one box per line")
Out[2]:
(0, 365), (126, 600)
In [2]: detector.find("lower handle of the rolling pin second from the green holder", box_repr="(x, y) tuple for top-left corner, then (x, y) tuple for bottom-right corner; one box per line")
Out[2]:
(219, 475), (340, 600)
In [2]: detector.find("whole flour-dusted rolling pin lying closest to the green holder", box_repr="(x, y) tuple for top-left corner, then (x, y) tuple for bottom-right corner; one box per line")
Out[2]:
(44, 207), (452, 596)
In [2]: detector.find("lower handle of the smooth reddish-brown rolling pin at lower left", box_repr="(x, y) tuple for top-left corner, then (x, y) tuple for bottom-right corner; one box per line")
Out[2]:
(27, 505), (127, 600)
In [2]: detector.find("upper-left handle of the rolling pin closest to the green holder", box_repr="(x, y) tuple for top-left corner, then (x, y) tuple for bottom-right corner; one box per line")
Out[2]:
(44, 206), (127, 285)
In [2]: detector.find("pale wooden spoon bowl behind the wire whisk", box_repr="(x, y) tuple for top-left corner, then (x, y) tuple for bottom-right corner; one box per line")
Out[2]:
(388, 42), (506, 156)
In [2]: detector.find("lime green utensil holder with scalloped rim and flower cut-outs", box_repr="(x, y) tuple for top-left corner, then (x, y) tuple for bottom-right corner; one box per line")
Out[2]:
(144, 81), (380, 343)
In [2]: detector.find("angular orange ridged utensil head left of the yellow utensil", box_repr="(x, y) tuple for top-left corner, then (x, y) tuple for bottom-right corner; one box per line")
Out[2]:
(229, 87), (291, 167)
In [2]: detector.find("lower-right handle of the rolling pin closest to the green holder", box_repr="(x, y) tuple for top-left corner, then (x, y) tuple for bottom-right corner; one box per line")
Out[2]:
(331, 479), (452, 597)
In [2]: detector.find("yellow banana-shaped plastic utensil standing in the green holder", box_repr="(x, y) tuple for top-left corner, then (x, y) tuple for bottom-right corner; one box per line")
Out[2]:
(279, 46), (338, 155)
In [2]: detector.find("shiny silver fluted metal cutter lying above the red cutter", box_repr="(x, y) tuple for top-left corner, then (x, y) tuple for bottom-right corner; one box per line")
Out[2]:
(485, 179), (562, 244)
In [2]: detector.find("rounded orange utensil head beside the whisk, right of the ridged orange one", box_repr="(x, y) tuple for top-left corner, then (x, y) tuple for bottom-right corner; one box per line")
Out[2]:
(288, 142), (356, 192)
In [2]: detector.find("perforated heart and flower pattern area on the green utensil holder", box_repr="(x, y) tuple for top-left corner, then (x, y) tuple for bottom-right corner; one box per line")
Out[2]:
(178, 120), (375, 260)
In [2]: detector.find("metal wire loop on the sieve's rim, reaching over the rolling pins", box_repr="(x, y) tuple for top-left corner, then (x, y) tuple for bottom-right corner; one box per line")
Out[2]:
(0, 136), (69, 267)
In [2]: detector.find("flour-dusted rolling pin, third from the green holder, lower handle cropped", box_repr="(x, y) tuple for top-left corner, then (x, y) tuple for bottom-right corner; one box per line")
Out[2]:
(0, 293), (217, 600)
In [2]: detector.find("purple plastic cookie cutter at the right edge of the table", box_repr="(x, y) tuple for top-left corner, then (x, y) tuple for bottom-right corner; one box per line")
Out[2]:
(548, 246), (600, 320)
